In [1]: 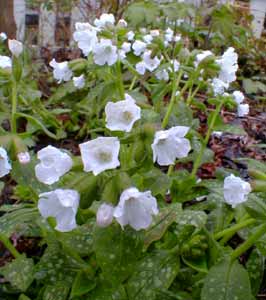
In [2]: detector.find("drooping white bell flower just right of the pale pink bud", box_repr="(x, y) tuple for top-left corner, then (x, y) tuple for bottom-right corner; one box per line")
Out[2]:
(114, 187), (159, 230)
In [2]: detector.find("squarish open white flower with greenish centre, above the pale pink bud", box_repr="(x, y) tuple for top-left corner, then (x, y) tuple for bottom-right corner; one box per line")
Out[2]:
(79, 137), (120, 176)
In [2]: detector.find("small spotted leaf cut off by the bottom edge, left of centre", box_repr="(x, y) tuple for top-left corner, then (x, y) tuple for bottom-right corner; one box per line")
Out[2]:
(42, 281), (69, 300)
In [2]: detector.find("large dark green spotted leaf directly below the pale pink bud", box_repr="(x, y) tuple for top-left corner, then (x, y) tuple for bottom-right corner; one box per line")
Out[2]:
(94, 224), (143, 284)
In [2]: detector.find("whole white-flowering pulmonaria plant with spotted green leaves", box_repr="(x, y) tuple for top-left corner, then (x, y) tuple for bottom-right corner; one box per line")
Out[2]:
(0, 8), (266, 300)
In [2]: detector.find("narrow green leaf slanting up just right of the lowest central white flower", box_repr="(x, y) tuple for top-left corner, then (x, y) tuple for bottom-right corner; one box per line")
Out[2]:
(144, 203), (182, 249)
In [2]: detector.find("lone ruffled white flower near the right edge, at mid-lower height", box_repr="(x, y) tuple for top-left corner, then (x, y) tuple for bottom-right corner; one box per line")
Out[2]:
(224, 174), (251, 207)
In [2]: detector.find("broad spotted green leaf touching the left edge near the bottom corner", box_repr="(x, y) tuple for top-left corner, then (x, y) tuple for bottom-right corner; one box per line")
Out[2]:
(0, 255), (34, 292)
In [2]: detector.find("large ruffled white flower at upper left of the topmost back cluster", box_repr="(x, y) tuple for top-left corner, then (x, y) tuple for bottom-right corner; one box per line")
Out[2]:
(73, 23), (98, 56)
